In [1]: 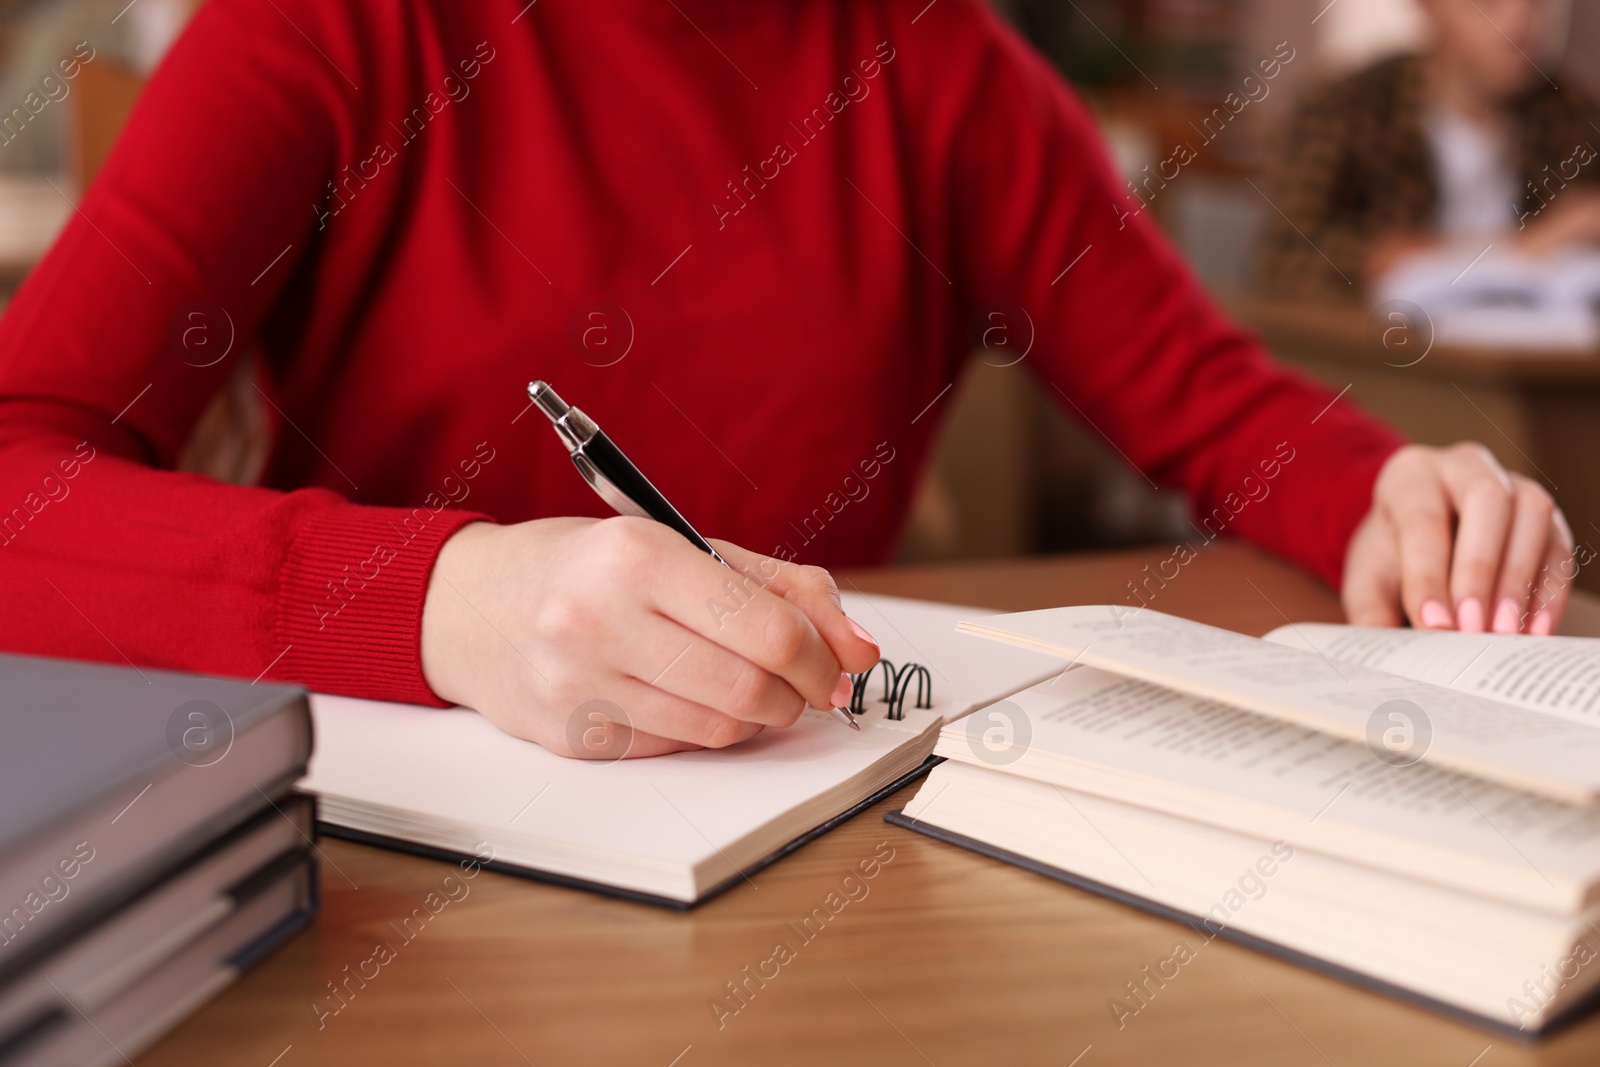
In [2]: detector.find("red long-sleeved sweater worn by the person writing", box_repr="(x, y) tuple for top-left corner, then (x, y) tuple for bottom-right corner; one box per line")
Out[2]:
(0, 0), (1397, 701)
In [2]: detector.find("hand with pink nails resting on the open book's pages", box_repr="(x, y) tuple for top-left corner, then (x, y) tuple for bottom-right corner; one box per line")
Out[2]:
(1344, 443), (1589, 633)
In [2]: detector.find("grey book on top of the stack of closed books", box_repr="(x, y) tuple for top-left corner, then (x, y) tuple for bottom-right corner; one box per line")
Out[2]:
(0, 654), (312, 973)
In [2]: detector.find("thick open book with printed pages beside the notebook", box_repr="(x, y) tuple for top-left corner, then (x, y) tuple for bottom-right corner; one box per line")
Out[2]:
(896, 608), (1600, 1032)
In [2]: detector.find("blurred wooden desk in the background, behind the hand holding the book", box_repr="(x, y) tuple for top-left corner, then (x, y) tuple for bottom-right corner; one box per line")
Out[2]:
(1222, 293), (1600, 592)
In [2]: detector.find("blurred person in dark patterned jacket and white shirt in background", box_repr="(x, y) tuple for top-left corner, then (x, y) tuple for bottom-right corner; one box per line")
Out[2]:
(1261, 0), (1600, 298)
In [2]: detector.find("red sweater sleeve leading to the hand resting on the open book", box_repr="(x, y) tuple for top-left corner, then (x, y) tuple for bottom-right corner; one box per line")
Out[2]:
(928, 3), (1402, 585)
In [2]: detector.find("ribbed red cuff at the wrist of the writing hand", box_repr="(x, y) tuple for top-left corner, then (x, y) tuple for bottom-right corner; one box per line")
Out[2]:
(270, 504), (488, 707)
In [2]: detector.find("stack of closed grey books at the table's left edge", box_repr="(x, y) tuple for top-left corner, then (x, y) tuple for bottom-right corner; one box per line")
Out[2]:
(0, 656), (317, 1067)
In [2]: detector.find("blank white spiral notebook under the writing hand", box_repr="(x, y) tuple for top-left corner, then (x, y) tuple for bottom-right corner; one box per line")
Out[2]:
(301, 593), (1061, 909)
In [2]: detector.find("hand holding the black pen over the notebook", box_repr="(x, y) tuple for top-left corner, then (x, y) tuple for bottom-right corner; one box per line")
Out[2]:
(422, 518), (878, 760)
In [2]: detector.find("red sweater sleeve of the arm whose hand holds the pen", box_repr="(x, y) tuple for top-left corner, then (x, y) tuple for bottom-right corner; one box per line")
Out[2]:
(0, 0), (482, 702)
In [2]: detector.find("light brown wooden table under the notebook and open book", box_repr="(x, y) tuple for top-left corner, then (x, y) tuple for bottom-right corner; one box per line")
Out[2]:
(138, 544), (1600, 1067)
